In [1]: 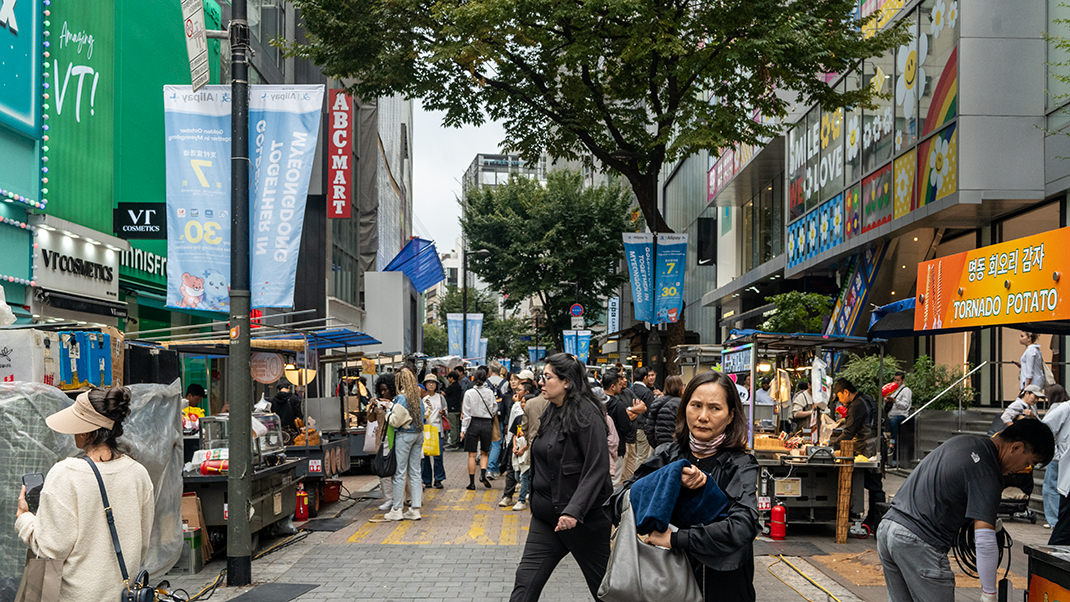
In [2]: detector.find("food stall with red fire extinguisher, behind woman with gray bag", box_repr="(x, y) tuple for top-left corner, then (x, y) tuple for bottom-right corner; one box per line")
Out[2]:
(721, 330), (883, 539)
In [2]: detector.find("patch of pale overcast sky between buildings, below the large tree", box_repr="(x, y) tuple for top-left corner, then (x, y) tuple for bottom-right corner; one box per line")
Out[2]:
(412, 101), (504, 252)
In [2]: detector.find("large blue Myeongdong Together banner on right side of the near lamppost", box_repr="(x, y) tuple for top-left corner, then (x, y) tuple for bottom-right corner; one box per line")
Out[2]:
(249, 86), (323, 308)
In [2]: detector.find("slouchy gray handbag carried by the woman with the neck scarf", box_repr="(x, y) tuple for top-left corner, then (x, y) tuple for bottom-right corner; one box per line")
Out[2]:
(598, 491), (705, 602)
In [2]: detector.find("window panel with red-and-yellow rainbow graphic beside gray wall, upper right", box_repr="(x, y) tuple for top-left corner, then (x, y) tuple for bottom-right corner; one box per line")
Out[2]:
(918, 0), (959, 137)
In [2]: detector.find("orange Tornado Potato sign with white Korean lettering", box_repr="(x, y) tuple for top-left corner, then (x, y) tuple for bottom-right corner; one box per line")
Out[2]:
(914, 228), (1070, 330)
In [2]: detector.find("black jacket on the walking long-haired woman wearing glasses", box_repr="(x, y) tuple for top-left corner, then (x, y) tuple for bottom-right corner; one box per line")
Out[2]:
(531, 402), (613, 525)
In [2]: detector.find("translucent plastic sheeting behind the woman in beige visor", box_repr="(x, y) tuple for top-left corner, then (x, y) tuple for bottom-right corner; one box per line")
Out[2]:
(0, 381), (182, 602)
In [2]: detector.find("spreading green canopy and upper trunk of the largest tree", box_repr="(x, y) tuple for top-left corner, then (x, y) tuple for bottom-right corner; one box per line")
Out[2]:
(288, 0), (910, 232)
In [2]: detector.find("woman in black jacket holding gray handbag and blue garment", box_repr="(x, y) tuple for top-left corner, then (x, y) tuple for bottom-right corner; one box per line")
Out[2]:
(598, 371), (759, 602)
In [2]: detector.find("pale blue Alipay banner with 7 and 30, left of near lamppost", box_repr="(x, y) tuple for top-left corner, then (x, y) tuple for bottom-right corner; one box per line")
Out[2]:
(164, 86), (230, 311)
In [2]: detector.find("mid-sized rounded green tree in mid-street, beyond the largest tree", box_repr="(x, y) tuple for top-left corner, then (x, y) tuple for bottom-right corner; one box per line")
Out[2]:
(461, 170), (635, 349)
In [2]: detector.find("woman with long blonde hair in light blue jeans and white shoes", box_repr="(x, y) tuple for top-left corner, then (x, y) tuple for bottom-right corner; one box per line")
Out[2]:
(383, 368), (424, 521)
